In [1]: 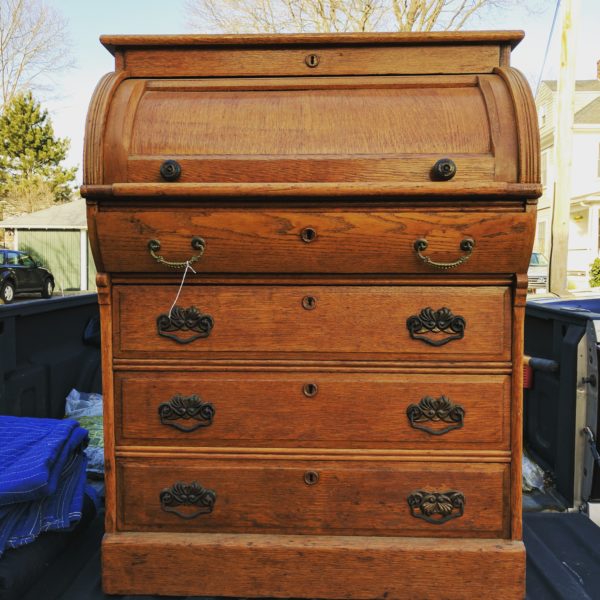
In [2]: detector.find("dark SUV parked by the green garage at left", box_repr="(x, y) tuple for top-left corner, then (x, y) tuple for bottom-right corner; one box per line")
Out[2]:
(0, 248), (54, 304)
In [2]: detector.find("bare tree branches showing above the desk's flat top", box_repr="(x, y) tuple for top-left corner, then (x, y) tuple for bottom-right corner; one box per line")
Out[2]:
(186, 0), (521, 33)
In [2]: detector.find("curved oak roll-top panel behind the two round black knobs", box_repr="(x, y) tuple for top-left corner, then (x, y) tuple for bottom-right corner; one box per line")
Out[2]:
(97, 75), (534, 186)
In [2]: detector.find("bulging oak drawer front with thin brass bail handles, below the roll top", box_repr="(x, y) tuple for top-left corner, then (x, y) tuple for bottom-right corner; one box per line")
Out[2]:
(95, 207), (535, 274)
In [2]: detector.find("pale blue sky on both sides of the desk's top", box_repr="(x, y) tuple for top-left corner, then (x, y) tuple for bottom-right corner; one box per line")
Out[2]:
(42, 0), (600, 183)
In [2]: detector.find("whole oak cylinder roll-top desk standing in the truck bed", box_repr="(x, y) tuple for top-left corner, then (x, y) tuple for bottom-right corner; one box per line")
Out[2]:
(82, 32), (541, 599)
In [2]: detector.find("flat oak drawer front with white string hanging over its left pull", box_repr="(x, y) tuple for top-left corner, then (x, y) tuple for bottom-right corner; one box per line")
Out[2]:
(114, 284), (511, 362)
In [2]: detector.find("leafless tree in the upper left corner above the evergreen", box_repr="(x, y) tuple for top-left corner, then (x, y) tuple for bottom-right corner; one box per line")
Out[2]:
(0, 0), (72, 106)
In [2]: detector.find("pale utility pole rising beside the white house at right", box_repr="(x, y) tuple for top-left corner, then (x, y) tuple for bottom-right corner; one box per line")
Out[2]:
(549, 0), (580, 296)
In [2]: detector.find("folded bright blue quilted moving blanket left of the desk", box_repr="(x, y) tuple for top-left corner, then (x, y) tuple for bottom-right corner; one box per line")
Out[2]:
(0, 416), (88, 556)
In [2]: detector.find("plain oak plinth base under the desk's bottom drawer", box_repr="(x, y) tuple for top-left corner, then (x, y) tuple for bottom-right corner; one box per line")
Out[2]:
(102, 533), (525, 600)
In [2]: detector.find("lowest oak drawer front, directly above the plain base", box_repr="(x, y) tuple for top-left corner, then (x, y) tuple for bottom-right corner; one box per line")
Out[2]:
(118, 457), (509, 537)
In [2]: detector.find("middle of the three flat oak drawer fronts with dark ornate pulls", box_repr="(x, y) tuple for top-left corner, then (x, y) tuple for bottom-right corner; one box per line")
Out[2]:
(115, 372), (510, 450)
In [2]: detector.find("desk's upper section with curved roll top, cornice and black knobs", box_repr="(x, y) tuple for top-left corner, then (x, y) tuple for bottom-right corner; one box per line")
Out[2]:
(84, 32), (539, 197)
